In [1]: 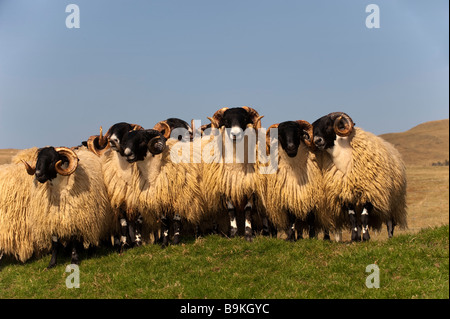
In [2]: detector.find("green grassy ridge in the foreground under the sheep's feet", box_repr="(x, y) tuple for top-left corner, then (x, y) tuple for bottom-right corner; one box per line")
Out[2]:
(0, 225), (449, 299)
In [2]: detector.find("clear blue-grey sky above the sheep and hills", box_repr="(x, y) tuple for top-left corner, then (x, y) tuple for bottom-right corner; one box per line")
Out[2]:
(0, 0), (449, 149)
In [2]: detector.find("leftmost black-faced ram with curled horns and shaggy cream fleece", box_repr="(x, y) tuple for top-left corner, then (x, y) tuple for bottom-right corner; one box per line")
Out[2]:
(22, 146), (112, 268)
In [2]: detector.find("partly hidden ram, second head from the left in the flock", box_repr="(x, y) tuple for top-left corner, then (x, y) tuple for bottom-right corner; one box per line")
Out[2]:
(85, 122), (147, 253)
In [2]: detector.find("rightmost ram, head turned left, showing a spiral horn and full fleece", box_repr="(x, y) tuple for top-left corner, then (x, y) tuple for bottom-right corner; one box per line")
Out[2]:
(313, 112), (407, 241)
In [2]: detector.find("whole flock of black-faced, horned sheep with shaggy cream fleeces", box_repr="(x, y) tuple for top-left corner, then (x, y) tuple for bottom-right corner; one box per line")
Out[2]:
(0, 106), (407, 268)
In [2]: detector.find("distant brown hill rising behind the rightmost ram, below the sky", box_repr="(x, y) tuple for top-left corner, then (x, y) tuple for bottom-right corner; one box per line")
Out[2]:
(380, 119), (449, 166)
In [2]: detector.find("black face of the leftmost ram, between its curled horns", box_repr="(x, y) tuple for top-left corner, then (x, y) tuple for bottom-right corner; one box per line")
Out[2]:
(35, 147), (68, 183)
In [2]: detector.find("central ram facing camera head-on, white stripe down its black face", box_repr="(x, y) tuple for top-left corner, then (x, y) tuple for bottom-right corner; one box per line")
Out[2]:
(202, 106), (263, 241)
